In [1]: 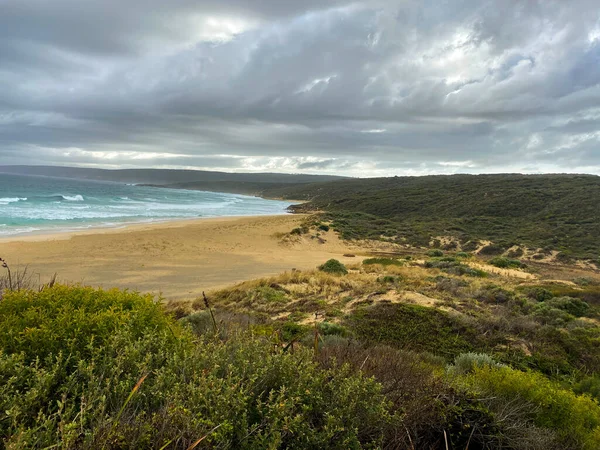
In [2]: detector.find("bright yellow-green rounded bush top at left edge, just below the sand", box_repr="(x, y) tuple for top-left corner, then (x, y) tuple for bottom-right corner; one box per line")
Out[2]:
(0, 286), (170, 364)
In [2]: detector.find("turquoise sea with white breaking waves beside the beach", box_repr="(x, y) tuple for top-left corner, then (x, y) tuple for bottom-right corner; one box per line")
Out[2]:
(0, 174), (290, 237)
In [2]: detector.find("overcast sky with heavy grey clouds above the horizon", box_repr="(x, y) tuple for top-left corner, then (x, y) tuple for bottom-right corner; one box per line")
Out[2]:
(0, 0), (600, 177)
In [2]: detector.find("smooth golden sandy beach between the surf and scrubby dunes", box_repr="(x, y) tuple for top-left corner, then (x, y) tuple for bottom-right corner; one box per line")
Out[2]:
(0, 215), (357, 300)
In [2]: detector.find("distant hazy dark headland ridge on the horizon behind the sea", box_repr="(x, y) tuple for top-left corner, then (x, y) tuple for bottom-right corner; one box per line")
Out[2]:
(0, 166), (342, 193)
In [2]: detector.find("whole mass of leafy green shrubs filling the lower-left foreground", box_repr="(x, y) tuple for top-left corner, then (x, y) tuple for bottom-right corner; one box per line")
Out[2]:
(0, 286), (390, 449)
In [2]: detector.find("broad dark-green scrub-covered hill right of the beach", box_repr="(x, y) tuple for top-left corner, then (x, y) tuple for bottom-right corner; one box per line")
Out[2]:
(266, 174), (600, 261)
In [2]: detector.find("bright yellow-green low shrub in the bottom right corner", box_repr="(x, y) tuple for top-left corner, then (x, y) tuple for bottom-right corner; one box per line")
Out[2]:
(464, 365), (600, 450)
